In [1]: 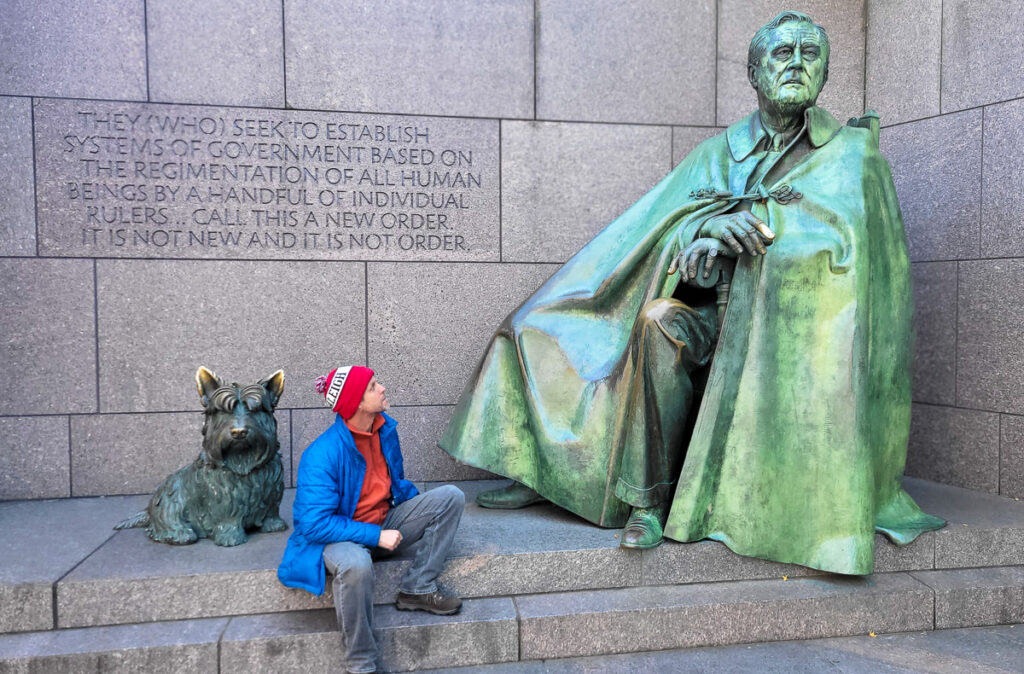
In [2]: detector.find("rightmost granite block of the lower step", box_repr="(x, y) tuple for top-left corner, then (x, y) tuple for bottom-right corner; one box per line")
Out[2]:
(911, 566), (1024, 630)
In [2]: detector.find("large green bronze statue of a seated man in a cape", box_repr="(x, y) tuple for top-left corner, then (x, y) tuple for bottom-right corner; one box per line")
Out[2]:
(439, 11), (944, 575)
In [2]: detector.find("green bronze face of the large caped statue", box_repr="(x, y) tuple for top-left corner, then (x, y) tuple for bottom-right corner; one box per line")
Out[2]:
(749, 22), (828, 113)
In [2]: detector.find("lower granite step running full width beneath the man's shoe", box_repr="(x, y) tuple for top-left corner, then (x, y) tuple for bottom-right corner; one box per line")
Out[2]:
(0, 566), (1024, 674)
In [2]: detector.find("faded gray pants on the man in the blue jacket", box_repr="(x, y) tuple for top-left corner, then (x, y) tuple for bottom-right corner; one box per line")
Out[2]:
(324, 485), (466, 672)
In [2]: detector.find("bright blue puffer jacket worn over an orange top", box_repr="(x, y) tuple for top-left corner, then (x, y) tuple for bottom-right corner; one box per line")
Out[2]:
(278, 414), (419, 594)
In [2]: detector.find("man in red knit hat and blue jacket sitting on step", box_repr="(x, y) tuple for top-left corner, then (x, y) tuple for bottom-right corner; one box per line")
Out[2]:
(278, 366), (466, 672)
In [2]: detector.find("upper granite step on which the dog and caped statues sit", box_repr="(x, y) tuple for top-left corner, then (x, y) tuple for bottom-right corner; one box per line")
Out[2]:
(6, 478), (1024, 632)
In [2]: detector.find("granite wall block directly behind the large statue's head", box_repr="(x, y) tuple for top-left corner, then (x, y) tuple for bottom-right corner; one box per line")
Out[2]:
(716, 0), (864, 126)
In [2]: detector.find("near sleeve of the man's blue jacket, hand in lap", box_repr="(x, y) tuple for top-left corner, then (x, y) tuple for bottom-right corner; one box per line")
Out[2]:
(294, 440), (381, 548)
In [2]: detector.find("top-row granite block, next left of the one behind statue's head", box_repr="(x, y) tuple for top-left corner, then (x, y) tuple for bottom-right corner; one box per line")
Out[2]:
(537, 0), (716, 124)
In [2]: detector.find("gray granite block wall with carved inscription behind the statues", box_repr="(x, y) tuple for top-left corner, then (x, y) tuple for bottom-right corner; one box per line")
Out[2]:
(0, 0), (1024, 499)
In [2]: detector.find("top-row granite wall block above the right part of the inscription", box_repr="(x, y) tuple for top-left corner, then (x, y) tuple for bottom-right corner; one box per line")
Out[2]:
(285, 0), (534, 118)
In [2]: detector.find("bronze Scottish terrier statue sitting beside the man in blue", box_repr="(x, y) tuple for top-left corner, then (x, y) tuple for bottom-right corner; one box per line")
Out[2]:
(114, 368), (288, 546)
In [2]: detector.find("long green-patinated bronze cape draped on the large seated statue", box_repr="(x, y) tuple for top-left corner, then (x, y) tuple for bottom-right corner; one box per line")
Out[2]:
(439, 108), (943, 574)
